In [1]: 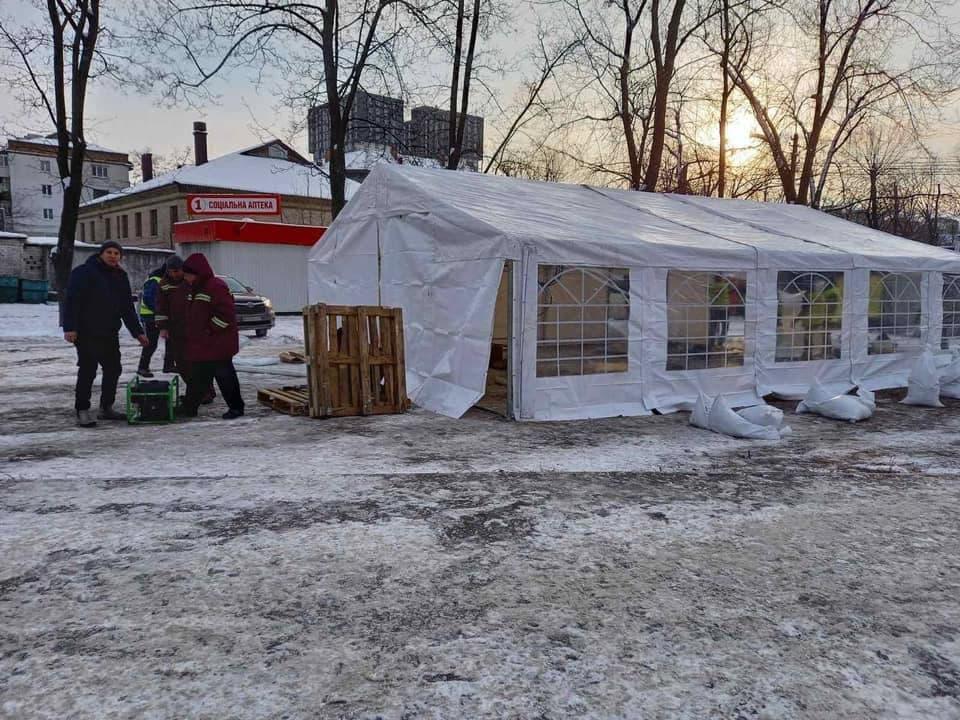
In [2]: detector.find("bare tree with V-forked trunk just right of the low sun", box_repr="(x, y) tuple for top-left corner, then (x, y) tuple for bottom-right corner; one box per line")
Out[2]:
(730, 0), (956, 205)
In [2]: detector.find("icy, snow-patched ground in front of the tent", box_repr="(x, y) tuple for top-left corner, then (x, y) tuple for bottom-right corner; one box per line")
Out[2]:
(0, 305), (960, 720)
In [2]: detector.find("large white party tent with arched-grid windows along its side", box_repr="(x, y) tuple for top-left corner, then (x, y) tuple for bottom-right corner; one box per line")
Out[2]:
(308, 164), (960, 420)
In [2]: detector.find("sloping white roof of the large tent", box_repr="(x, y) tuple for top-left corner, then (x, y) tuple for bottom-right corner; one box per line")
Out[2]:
(343, 163), (960, 271)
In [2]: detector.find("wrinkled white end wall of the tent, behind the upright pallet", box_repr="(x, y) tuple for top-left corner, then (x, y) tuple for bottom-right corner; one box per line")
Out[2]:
(309, 200), (504, 417)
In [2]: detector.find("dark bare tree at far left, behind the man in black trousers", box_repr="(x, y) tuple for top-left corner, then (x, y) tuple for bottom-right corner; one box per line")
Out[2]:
(0, 0), (108, 307)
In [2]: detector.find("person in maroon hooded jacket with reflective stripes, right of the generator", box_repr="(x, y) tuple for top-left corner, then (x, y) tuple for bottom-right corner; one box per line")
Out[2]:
(180, 253), (244, 420)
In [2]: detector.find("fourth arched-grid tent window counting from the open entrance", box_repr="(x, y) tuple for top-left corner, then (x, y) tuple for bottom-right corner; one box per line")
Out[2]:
(867, 271), (923, 355)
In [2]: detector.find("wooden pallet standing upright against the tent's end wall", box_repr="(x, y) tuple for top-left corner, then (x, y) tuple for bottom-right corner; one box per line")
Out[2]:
(303, 305), (409, 418)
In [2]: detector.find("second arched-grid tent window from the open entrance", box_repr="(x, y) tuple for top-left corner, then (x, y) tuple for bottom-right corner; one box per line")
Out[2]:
(667, 270), (747, 370)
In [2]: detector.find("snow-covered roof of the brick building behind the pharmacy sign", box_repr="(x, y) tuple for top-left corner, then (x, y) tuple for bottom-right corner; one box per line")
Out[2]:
(83, 145), (359, 207)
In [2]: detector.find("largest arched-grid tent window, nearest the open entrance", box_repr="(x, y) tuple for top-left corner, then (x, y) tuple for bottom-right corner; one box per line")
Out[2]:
(537, 265), (630, 377)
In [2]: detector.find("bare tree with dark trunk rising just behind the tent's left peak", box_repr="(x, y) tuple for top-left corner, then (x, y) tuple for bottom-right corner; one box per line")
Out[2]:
(134, 0), (422, 217)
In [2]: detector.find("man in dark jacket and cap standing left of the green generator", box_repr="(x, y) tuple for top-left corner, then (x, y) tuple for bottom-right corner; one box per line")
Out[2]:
(63, 240), (149, 427)
